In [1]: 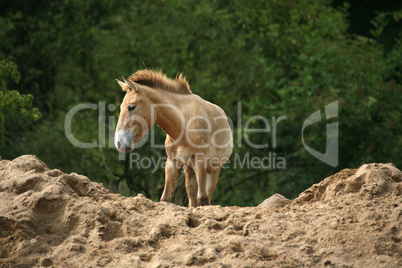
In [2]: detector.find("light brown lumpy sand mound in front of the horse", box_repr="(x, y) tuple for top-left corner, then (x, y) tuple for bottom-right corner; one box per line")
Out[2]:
(0, 156), (402, 267)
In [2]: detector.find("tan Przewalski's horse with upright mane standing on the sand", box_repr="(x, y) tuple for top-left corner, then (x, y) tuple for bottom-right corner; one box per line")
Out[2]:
(115, 70), (233, 207)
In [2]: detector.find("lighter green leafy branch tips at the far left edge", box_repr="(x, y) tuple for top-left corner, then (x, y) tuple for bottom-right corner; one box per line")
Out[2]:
(0, 60), (41, 143)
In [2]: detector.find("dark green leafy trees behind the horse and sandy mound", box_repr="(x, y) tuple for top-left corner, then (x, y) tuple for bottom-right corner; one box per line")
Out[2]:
(0, 0), (402, 206)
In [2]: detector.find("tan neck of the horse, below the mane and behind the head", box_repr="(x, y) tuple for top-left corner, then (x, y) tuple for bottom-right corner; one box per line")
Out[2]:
(150, 90), (185, 139)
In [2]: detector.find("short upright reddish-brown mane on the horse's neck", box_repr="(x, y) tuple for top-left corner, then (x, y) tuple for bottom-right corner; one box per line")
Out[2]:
(128, 69), (192, 95)
